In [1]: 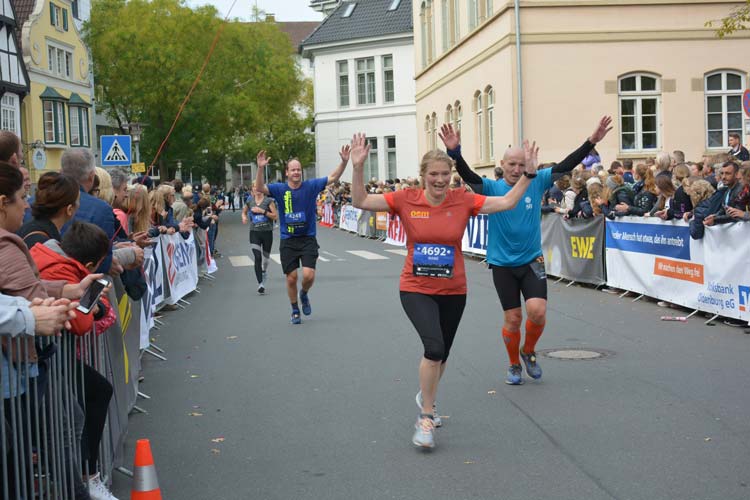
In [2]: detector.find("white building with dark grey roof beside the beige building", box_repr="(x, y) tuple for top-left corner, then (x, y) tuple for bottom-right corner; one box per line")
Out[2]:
(301, 0), (418, 180)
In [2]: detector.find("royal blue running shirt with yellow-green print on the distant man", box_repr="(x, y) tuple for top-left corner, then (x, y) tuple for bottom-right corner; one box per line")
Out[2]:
(268, 177), (328, 240)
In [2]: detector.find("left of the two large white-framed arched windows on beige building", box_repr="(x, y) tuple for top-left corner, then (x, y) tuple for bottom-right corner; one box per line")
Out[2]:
(617, 72), (662, 153)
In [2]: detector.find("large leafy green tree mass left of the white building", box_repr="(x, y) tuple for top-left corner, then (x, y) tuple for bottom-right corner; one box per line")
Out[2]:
(84, 0), (304, 179)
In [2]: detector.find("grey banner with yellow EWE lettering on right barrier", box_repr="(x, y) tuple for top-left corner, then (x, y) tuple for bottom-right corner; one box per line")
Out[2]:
(542, 214), (606, 285)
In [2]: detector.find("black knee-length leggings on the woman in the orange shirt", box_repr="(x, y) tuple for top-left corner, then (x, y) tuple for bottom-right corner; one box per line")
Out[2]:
(401, 292), (466, 363)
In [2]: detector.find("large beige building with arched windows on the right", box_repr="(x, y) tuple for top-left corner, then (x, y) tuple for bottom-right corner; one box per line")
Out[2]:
(413, 0), (750, 170)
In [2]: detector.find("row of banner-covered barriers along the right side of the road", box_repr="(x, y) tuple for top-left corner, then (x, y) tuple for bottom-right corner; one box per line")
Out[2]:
(329, 205), (750, 321)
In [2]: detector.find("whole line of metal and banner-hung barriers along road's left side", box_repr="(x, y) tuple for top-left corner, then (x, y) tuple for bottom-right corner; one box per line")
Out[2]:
(0, 230), (217, 500)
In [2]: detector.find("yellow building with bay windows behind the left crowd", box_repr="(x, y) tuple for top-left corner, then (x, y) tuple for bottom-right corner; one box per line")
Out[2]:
(16, 0), (93, 182)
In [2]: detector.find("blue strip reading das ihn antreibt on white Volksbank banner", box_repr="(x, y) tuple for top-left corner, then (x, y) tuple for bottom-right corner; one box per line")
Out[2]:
(606, 222), (690, 260)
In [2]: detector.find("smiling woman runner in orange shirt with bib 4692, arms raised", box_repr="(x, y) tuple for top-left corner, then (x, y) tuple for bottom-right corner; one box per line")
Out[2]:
(351, 134), (537, 448)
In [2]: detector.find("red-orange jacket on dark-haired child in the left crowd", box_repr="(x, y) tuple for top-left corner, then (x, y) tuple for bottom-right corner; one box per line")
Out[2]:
(30, 240), (105, 336)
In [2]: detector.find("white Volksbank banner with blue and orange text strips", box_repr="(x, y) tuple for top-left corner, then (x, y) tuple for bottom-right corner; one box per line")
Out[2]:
(605, 217), (750, 320)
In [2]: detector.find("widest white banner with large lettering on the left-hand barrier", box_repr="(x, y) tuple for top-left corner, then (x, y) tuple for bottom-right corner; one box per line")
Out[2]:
(161, 233), (198, 304)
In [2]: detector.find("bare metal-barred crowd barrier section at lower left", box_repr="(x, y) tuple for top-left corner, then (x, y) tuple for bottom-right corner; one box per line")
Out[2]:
(0, 332), (113, 500)
